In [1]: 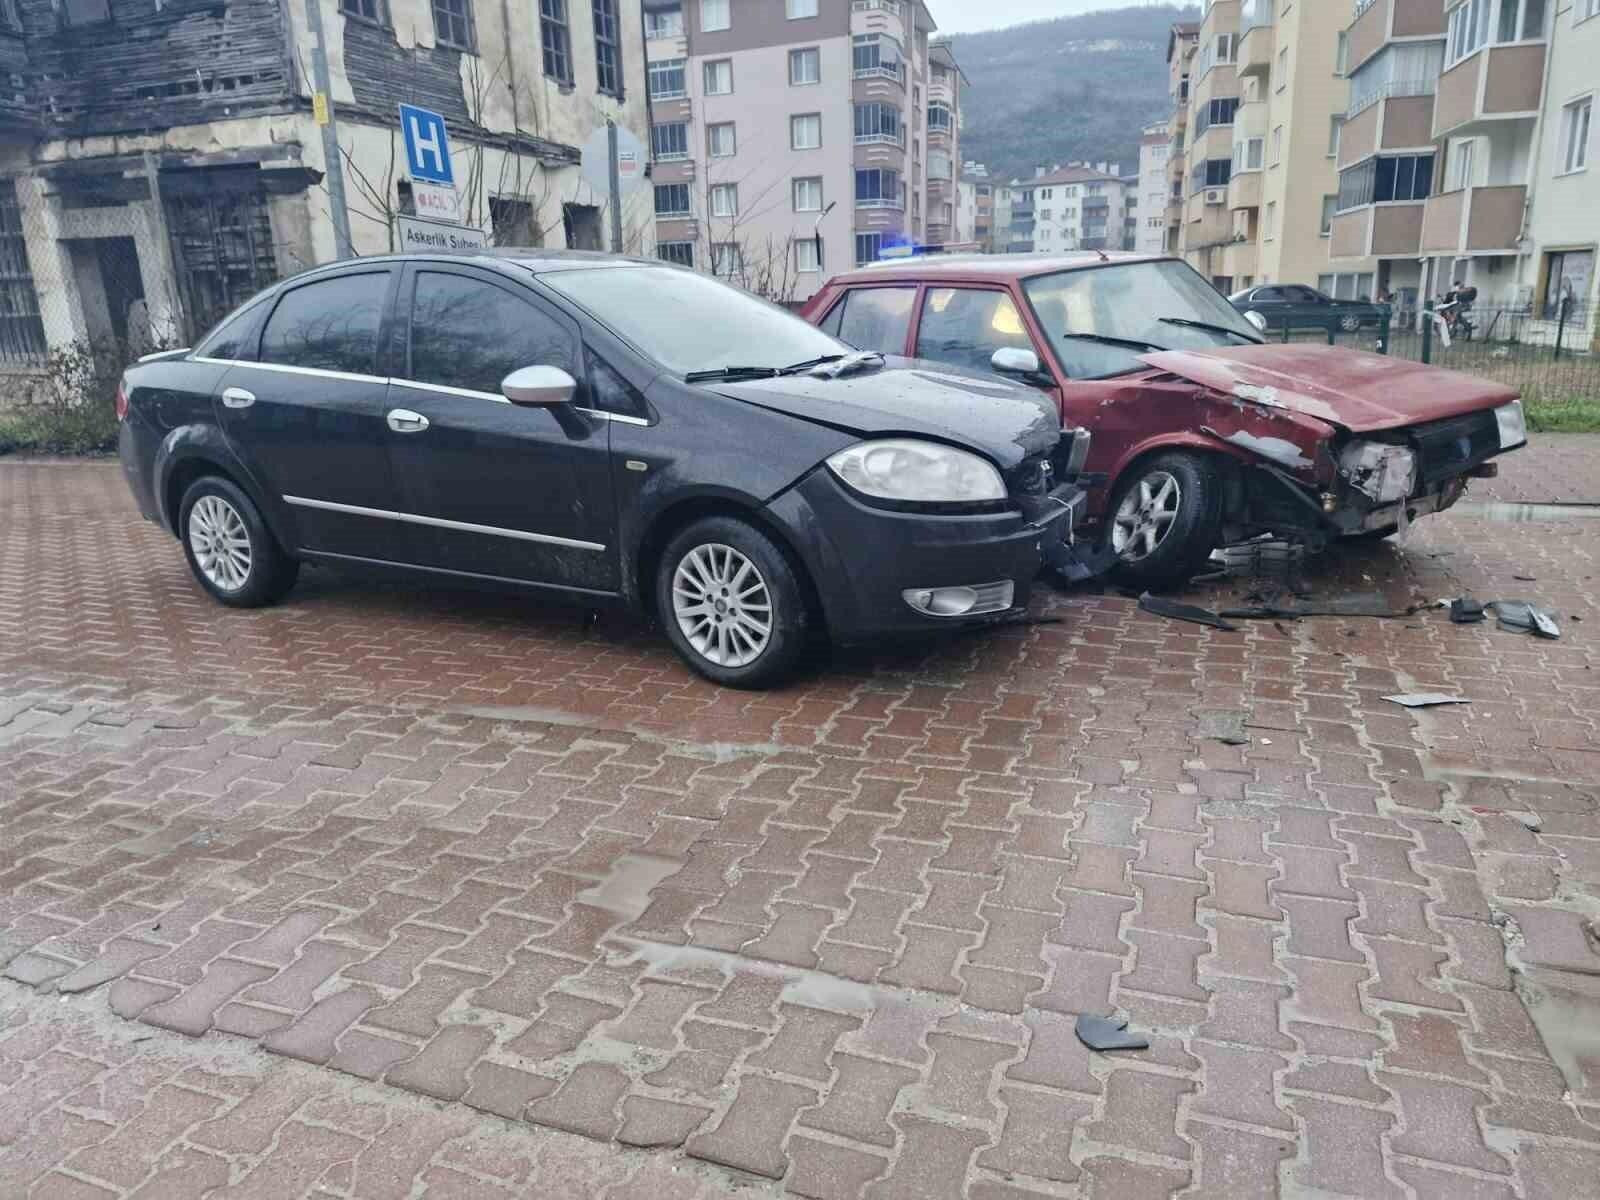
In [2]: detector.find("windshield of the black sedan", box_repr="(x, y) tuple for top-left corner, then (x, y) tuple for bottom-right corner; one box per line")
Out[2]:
(539, 267), (850, 374)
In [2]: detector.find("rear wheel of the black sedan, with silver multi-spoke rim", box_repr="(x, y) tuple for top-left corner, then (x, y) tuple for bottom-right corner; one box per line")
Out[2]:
(178, 475), (299, 608)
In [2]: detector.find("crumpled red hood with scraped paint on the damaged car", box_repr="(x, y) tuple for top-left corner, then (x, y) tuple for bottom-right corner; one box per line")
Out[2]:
(1141, 342), (1517, 432)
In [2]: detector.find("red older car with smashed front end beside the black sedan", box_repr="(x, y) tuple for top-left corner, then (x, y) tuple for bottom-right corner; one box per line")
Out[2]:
(803, 253), (1526, 586)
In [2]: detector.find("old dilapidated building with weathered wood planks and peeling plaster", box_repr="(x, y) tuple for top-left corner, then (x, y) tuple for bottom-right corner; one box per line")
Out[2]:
(0, 0), (653, 370)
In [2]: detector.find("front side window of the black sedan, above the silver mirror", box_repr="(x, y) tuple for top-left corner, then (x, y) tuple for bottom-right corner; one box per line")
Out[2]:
(408, 270), (579, 395)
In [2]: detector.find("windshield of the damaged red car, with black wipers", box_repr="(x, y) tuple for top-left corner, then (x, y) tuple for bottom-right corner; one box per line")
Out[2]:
(1022, 259), (1261, 379)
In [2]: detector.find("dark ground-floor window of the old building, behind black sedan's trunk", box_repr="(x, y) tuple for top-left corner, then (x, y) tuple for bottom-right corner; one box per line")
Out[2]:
(162, 185), (278, 340)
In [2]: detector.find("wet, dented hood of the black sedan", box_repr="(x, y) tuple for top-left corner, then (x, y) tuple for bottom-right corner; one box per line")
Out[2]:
(702, 358), (1061, 470)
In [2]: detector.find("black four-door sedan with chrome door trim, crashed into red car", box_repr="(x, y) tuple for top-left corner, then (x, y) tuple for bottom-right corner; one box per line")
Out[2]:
(117, 251), (1086, 686)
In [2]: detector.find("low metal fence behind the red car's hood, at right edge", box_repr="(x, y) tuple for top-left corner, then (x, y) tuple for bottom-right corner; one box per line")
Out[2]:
(1270, 304), (1600, 410)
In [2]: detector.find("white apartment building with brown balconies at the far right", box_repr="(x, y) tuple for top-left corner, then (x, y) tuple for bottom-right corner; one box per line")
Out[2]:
(1333, 0), (1600, 338)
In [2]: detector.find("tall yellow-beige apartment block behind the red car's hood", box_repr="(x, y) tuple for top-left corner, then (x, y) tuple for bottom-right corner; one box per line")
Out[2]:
(1168, 0), (1374, 298)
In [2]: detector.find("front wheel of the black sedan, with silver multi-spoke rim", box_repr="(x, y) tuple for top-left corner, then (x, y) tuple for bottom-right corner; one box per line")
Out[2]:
(656, 517), (810, 688)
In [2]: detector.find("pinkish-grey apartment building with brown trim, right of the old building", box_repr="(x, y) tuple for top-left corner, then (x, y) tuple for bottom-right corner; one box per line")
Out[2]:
(645, 0), (962, 301)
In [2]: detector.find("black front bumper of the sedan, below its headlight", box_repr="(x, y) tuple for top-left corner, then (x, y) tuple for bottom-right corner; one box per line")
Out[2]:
(768, 467), (1086, 642)
